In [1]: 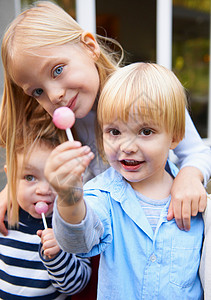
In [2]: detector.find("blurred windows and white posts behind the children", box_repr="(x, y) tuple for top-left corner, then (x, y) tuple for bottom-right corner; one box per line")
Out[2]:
(0, 0), (211, 188)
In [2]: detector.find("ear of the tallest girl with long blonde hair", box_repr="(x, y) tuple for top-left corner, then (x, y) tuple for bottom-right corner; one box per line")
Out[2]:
(81, 31), (100, 61)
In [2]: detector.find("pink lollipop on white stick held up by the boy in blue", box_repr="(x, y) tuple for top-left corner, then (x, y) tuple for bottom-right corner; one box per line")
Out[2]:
(53, 106), (75, 141)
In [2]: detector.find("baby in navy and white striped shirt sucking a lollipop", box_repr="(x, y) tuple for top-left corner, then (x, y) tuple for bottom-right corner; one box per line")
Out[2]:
(0, 120), (91, 300)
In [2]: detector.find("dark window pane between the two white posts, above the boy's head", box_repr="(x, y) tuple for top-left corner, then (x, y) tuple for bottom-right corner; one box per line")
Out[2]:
(96, 0), (156, 63)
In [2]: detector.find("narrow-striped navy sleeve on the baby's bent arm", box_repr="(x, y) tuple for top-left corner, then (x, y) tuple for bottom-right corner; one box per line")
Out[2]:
(39, 245), (91, 295)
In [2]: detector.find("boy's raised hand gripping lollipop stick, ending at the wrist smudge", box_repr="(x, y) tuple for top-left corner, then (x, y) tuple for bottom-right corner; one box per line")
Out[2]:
(45, 141), (94, 206)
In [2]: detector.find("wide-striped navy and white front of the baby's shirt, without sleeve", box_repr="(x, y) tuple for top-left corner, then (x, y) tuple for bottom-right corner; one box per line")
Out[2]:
(0, 226), (66, 300)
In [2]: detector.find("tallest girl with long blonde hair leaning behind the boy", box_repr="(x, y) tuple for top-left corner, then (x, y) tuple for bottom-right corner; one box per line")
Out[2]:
(0, 1), (211, 234)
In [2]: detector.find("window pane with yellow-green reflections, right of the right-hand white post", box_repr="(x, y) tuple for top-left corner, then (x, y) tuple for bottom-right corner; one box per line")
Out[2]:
(173, 0), (210, 137)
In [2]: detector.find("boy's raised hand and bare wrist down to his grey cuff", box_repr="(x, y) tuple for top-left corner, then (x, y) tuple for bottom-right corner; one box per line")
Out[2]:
(45, 141), (94, 224)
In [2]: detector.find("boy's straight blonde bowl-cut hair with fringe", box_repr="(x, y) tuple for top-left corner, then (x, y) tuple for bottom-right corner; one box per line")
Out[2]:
(97, 63), (187, 159)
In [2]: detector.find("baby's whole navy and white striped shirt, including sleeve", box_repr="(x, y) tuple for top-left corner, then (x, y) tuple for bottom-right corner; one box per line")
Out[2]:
(0, 209), (91, 300)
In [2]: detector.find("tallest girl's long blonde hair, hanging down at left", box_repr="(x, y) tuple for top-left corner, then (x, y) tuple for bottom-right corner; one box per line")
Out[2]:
(0, 1), (123, 225)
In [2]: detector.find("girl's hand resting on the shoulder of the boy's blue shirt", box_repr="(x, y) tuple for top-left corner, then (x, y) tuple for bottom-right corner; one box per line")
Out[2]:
(167, 167), (207, 231)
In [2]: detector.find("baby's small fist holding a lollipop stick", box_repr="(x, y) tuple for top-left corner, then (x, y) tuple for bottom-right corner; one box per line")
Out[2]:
(37, 228), (60, 259)
